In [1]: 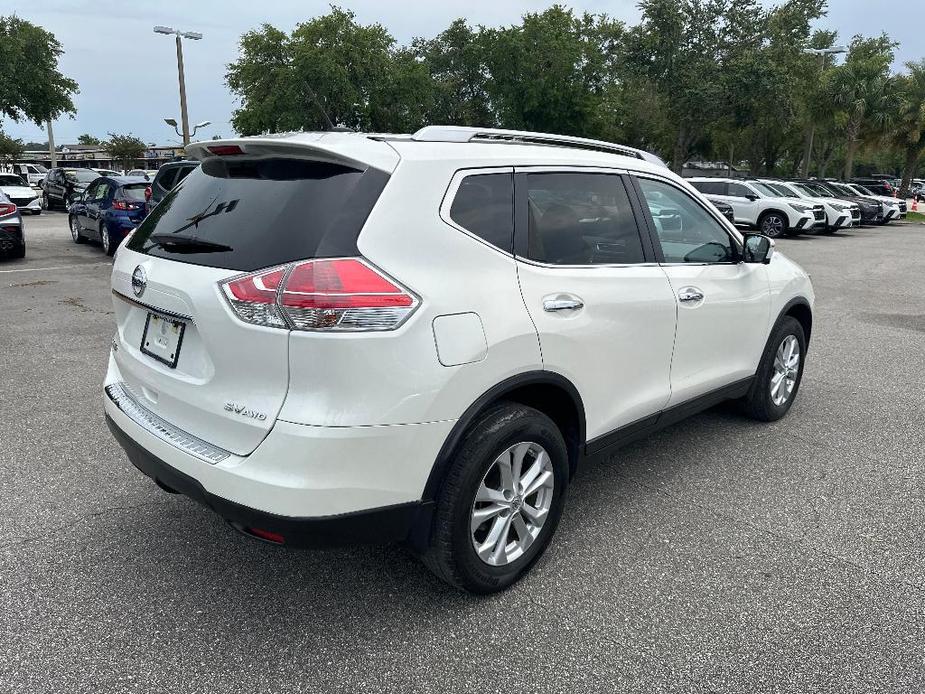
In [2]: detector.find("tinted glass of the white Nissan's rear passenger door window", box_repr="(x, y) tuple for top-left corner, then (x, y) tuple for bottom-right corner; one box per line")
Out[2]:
(527, 173), (645, 265)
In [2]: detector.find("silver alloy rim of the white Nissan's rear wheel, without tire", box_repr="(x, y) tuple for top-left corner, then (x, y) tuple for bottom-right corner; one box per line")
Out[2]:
(470, 442), (555, 566)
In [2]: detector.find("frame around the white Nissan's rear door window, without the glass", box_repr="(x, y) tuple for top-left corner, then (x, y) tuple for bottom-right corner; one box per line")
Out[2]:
(514, 165), (659, 270)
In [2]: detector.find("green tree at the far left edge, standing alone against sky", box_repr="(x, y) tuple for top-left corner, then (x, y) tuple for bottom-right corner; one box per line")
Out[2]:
(0, 15), (78, 125)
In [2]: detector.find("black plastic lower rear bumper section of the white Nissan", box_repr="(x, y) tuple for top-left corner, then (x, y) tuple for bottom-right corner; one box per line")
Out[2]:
(106, 414), (433, 547)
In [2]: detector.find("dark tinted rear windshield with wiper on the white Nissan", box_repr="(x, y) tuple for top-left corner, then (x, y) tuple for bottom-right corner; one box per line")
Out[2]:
(128, 157), (388, 271)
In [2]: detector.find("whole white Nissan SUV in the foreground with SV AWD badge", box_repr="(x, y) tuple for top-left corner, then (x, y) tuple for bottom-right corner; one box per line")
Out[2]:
(103, 127), (813, 592)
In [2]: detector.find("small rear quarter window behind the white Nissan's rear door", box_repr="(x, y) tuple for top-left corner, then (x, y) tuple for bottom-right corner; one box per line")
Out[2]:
(450, 173), (514, 253)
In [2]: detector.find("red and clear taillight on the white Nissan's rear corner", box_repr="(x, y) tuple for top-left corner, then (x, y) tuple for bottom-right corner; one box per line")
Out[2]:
(221, 258), (418, 331)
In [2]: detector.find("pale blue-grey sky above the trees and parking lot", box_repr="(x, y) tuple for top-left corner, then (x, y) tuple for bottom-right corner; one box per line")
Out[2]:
(0, 0), (925, 145)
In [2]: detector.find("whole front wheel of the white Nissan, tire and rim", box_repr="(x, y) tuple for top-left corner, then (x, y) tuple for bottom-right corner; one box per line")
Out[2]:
(742, 316), (806, 422)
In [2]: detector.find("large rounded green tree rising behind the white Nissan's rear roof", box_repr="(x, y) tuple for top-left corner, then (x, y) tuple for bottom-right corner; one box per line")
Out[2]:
(226, 6), (431, 134)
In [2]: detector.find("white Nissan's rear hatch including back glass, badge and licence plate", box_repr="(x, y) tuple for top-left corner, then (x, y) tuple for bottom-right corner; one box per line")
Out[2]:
(112, 136), (397, 455)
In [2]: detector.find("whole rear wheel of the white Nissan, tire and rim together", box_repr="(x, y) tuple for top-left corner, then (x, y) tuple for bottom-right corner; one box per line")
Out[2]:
(422, 403), (569, 593)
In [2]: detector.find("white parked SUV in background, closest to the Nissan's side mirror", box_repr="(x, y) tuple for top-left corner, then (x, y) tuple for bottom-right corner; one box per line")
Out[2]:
(687, 178), (825, 238)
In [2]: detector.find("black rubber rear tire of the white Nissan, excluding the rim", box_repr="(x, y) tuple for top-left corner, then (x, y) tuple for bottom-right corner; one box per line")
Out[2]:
(421, 403), (569, 593)
